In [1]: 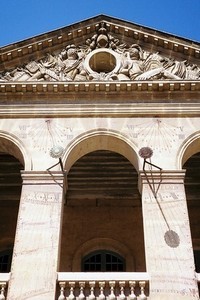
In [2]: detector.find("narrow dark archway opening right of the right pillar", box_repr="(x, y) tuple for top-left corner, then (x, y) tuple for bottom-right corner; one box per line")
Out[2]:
(183, 152), (200, 273)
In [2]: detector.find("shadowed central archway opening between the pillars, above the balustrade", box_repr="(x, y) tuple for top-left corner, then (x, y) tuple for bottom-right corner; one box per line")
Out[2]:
(60, 148), (146, 272)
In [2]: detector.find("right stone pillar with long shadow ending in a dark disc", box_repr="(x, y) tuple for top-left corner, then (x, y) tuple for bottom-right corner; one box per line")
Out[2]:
(140, 171), (199, 300)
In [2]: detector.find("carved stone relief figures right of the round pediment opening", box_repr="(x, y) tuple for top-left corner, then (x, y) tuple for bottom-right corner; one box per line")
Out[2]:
(118, 44), (200, 80)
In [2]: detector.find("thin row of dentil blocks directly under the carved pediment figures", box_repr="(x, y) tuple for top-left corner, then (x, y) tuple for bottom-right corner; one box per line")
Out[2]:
(0, 80), (200, 96)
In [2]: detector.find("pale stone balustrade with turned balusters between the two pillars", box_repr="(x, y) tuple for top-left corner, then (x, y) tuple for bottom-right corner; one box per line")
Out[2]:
(56, 272), (149, 300)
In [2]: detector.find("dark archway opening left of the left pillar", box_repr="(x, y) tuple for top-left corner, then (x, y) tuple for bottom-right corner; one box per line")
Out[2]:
(0, 138), (24, 272)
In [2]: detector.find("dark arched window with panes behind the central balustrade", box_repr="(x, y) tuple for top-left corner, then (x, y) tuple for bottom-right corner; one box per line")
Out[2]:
(82, 250), (125, 272)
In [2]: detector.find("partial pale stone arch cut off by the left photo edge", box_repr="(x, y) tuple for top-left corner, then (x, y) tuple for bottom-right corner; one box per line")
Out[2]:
(0, 131), (32, 171)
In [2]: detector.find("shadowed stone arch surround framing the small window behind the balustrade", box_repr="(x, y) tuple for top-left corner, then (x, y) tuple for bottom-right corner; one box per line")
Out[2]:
(72, 238), (135, 272)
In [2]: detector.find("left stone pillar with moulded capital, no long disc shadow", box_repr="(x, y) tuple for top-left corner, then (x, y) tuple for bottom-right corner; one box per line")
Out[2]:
(7, 172), (65, 300)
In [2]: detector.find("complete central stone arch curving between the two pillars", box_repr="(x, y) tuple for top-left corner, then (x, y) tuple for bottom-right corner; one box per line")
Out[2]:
(63, 129), (139, 171)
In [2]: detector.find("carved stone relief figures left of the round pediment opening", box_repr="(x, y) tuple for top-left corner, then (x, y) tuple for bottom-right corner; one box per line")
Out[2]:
(0, 45), (86, 81)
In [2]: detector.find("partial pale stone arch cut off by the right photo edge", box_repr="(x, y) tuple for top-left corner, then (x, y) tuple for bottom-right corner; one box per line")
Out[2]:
(177, 131), (200, 169)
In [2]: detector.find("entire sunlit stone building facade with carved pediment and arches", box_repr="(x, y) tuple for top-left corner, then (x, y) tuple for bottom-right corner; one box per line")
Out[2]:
(0, 15), (200, 300)
